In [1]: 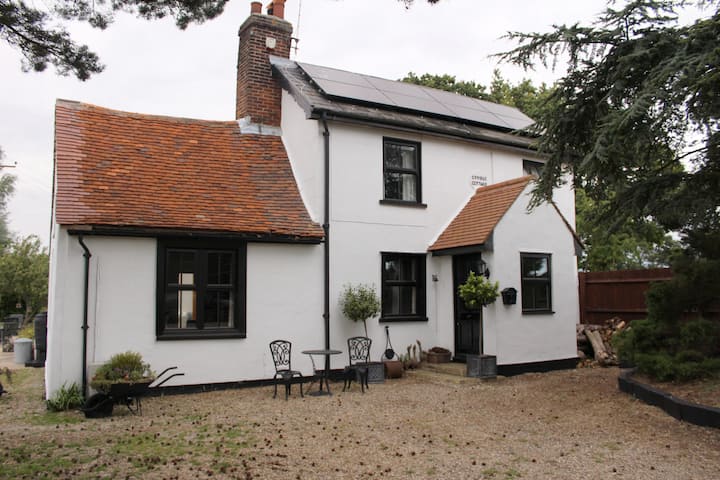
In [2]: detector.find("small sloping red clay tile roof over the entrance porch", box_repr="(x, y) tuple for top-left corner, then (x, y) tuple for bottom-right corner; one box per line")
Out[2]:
(428, 175), (533, 252)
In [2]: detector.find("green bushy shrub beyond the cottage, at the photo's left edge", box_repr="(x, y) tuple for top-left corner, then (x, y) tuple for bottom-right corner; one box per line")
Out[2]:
(0, 235), (49, 324)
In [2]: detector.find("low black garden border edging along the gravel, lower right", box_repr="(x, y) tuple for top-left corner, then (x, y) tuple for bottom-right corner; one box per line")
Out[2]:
(618, 369), (720, 428)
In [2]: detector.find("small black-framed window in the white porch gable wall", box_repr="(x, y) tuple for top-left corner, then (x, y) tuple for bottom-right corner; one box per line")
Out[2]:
(520, 253), (552, 313)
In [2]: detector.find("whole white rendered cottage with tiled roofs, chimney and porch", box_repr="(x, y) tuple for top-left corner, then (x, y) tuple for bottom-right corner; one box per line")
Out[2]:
(46, 0), (578, 395)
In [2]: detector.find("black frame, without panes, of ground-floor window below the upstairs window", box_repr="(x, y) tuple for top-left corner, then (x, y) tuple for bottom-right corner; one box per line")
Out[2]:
(380, 252), (428, 322)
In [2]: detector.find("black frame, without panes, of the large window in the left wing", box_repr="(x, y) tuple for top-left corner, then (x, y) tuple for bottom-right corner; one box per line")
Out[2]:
(155, 239), (247, 340)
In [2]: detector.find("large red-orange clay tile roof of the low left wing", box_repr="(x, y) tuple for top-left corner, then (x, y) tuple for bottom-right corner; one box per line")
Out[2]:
(55, 100), (323, 239)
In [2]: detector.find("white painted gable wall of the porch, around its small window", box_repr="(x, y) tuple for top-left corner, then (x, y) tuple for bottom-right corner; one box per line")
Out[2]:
(483, 186), (579, 365)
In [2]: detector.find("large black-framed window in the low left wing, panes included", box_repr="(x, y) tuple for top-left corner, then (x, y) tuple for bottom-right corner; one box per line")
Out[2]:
(157, 240), (246, 340)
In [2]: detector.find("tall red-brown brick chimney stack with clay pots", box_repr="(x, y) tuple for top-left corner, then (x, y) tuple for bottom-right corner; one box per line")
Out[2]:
(235, 0), (292, 127)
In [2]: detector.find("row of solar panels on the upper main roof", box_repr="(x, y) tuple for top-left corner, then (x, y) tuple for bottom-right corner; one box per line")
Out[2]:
(297, 62), (533, 130)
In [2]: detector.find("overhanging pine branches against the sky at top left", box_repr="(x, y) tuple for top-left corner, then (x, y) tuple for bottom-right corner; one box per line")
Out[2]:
(0, 0), (228, 80)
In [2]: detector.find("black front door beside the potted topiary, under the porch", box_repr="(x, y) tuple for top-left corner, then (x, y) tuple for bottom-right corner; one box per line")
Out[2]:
(453, 253), (485, 361)
